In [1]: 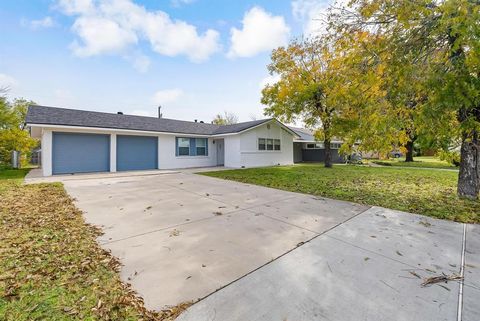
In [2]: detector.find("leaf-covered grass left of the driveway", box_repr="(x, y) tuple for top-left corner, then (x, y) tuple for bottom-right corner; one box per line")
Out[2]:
(0, 184), (189, 321)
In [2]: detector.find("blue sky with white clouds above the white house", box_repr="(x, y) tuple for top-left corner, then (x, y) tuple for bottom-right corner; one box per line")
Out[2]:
(0, 0), (327, 122)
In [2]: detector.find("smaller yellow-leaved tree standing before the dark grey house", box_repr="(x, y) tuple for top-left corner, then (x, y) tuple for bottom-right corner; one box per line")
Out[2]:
(261, 38), (344, 167)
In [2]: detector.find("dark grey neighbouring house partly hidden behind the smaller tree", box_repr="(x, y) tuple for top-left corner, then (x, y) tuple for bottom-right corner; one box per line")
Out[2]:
(289, 127), (345, 163)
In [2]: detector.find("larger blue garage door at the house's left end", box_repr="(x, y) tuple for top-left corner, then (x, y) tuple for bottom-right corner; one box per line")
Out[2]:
(52, 133), (110, 174)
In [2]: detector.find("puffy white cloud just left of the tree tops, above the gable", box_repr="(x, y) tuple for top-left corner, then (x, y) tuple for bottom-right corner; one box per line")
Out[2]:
(228, 7), (290, 57)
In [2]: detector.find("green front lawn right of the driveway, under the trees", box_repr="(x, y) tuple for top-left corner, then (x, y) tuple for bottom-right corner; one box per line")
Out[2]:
(201, 164), (480, 223)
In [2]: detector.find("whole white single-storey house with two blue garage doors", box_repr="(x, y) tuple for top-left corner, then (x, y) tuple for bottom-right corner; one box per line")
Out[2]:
(26, 106), (297, 176)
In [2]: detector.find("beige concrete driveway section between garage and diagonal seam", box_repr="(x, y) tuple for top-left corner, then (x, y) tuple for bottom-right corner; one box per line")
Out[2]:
(63, 172), (368, 309)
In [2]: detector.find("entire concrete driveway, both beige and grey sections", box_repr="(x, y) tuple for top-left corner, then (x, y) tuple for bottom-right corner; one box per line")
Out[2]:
(51, 171), (480, 321)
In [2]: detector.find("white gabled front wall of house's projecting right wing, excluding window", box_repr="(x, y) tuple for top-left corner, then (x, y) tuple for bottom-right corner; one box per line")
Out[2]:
(235, 122), (293, 167)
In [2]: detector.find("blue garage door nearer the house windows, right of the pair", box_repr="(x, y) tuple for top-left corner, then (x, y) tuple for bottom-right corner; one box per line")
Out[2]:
(117, 135), (158, 171)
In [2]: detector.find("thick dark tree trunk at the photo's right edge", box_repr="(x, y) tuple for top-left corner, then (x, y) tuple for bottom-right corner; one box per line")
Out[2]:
(457, 131), (480, 199)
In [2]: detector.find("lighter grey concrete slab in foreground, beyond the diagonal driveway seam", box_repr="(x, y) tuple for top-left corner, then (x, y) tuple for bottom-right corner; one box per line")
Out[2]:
(177, 208), (480, 321)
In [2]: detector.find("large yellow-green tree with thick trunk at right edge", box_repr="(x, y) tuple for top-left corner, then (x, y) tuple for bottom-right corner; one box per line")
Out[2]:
(328, 0), (480, 198)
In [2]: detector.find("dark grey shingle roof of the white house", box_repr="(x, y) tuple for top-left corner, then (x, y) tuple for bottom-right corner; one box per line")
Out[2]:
(26, 105), (271, 135)
